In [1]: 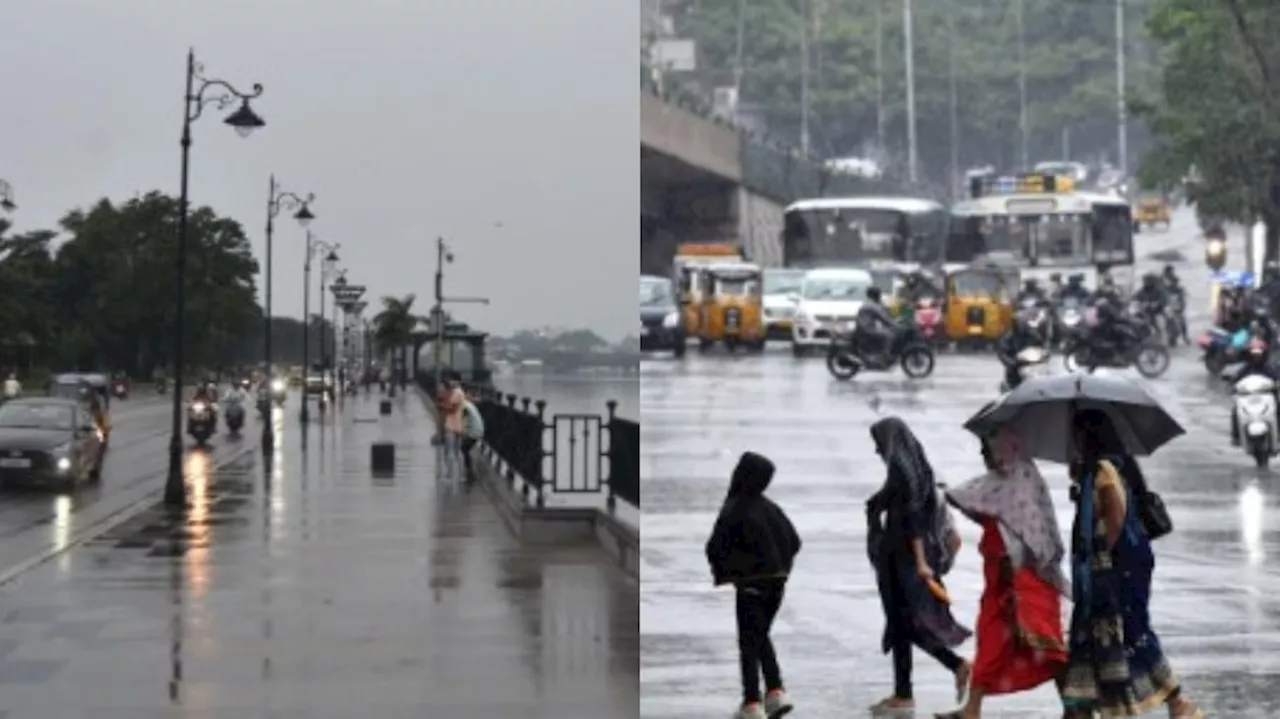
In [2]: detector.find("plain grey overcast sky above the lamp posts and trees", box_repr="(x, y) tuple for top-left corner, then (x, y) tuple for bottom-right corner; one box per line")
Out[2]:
(0, 0), (639, 338)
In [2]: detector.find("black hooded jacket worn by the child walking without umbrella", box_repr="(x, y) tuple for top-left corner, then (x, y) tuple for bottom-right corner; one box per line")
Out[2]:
(707, 452), (800, 585)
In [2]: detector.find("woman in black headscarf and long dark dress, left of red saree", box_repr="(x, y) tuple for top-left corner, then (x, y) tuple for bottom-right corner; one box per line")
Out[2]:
(867, 417), (972, 711)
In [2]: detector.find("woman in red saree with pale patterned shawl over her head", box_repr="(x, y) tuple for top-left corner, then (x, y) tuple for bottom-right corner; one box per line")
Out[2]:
(936, 430), (1070, 719)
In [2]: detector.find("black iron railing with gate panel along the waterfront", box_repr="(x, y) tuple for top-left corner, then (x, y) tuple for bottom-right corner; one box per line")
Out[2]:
(419, 375), (640, 512)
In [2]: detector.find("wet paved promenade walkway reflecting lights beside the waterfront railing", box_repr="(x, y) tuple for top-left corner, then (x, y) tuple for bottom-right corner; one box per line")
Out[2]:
(0, 388), (639, 719)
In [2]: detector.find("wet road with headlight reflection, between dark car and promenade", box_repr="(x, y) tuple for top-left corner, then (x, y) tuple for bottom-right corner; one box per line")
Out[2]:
(0, 393), (260, 581)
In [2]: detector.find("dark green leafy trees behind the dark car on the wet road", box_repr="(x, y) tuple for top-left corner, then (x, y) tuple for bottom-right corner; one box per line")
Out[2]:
(0, 192), (276, 375)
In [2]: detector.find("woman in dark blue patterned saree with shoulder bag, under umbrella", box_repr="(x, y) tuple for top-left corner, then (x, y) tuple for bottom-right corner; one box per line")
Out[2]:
(1061, 409), (1203, 719)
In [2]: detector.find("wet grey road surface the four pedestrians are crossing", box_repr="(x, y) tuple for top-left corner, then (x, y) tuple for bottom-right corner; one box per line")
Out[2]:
(640, 211), (1280, 719)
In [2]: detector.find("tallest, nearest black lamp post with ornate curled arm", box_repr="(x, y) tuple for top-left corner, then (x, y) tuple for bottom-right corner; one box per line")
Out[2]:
(164, 50), (266, 507)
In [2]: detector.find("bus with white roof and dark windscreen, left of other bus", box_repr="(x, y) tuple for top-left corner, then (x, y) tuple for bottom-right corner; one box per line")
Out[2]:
(782, 197), (948, 267)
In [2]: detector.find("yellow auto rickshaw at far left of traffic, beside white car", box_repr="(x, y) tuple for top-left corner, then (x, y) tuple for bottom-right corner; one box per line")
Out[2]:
(695, 262), (768, 352)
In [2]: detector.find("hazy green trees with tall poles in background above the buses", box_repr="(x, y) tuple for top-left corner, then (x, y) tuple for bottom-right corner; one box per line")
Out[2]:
(681, 0), (1162, 173)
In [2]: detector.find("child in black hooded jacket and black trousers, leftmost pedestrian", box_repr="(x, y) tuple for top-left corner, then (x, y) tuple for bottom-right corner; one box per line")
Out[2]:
(707, 452), (800, 719)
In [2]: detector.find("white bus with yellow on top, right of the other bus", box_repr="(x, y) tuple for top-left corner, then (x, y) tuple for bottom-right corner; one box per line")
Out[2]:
(946, 173), (1134, 290)
